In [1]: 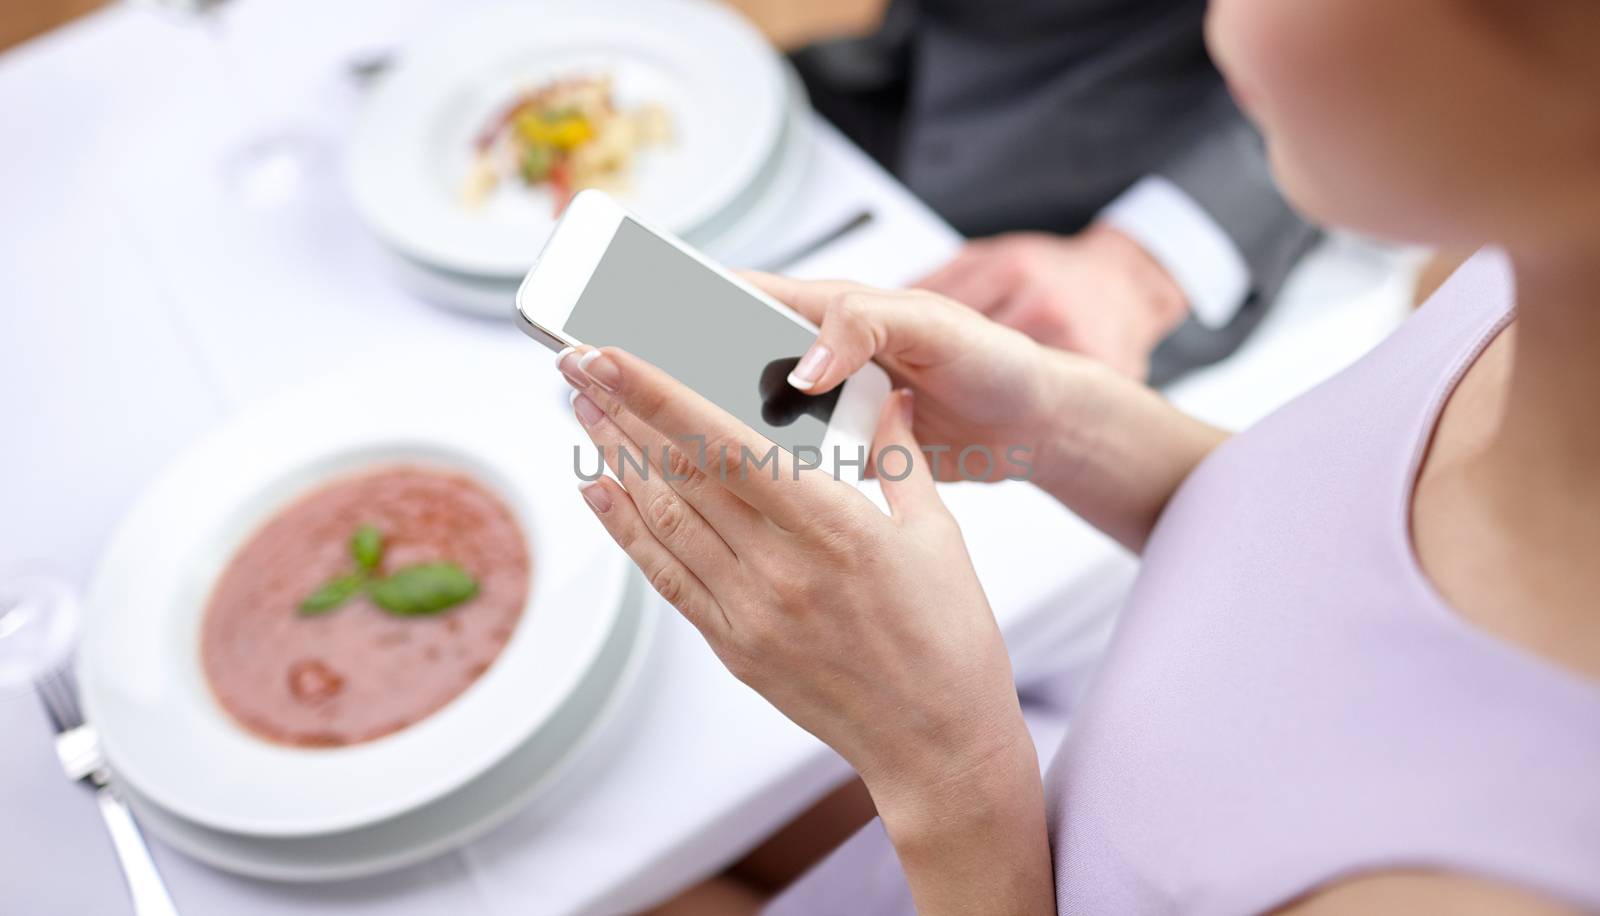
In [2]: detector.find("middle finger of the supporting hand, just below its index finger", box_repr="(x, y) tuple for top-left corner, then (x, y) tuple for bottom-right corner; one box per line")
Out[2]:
(557, 348), (765, 544)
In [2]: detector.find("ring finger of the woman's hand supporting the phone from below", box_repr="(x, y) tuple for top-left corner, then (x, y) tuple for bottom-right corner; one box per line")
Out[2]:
(573, 387), (739, 588)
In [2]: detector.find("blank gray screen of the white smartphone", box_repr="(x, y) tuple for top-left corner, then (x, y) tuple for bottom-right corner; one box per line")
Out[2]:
(565, 218), (843, 452)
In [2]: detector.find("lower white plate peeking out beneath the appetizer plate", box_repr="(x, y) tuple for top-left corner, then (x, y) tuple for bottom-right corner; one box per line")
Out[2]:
(384, 74), (813, 320)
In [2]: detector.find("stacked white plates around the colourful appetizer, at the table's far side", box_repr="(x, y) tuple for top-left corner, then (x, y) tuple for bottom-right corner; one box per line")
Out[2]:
(346, 0), (810, 317)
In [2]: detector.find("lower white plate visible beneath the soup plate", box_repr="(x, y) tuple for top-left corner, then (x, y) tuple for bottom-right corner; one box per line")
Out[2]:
(116, 573), (661, 882)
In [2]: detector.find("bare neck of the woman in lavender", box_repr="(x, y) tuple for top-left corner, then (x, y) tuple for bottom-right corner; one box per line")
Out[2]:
(1478, 242), (1600, 515)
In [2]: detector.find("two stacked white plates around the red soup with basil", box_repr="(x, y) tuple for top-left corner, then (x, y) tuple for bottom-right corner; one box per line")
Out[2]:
(78, 367), (656, 881)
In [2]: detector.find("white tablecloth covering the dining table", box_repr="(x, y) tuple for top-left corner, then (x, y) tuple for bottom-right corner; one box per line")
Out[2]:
(0, 0), (1406, 914)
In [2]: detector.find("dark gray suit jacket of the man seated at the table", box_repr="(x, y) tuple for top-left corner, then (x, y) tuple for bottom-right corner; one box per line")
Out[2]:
(795, 0), (1317, 381)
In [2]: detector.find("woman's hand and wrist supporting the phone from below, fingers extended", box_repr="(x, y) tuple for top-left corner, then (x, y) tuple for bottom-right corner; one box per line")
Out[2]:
(560, 348), (1053, 913)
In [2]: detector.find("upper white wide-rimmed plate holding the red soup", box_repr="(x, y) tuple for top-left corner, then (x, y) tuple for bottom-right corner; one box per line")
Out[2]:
(78, 357), (626, 836)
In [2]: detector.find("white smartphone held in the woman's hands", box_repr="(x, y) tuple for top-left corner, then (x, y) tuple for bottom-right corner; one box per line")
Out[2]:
(517, 191), (890, 482)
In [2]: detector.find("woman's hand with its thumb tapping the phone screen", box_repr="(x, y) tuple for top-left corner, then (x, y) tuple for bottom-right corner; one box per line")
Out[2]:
(746, 274), (1224, 551)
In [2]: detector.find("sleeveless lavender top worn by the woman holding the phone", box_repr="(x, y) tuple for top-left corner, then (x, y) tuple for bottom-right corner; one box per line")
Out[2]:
(768, 250), (1600, 916)
